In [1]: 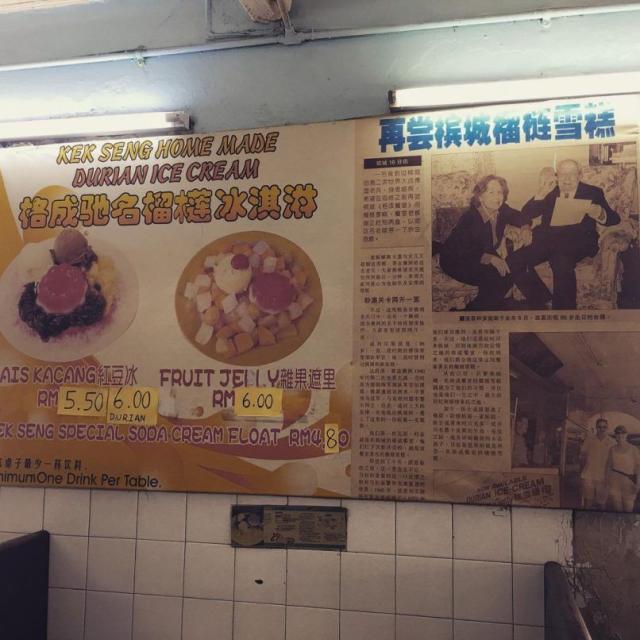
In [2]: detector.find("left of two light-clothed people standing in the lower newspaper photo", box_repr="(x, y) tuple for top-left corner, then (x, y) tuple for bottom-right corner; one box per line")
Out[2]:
(580, 418), (615, 509)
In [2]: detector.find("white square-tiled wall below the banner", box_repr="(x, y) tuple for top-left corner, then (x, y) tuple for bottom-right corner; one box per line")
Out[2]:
(0, 487), (572, 640)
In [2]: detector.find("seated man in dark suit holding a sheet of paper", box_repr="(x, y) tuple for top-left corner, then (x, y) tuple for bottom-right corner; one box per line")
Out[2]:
(509, 160), (620, 309)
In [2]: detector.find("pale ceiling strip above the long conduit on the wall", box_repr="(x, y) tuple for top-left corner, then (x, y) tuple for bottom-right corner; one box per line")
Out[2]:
(0, 0), (640, 69)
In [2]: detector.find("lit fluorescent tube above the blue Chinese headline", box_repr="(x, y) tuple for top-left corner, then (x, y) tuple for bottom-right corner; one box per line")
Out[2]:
(389, 71), (640, 111)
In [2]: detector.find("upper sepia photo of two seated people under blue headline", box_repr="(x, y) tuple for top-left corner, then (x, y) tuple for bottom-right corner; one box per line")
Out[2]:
(431, 142), (640, 312)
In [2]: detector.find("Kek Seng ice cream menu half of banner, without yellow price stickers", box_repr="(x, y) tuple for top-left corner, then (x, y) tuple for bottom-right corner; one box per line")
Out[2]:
(0, 123), (353, 495)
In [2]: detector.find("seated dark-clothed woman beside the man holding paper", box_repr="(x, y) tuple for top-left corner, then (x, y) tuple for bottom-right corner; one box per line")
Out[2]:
(440, 175), (549, 311)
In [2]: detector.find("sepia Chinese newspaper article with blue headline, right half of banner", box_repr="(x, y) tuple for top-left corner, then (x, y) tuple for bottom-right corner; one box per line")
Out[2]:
(353, 97), (640, 510)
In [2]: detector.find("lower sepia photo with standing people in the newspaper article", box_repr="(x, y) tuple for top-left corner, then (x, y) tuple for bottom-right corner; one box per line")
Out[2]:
(509, 332), (640, 512)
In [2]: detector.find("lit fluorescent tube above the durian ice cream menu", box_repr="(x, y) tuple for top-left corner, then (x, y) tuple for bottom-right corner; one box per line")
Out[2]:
(0, 111), (189, 142)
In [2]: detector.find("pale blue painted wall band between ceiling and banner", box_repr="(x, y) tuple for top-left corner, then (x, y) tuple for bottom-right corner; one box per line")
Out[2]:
(0, 12), (640, 131)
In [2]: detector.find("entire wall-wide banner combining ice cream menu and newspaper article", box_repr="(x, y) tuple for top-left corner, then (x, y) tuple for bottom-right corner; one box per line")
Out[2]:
(0, 96), (640, 510)
